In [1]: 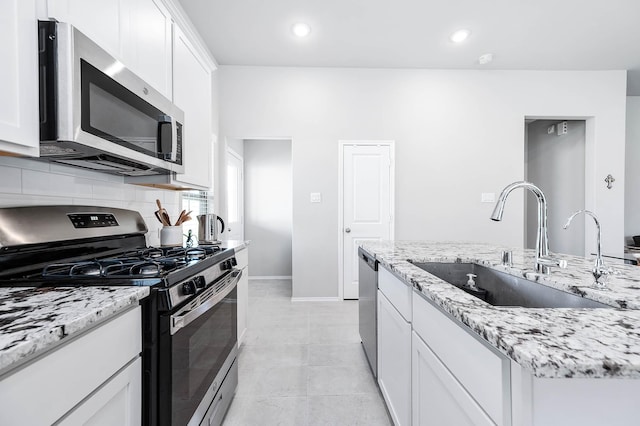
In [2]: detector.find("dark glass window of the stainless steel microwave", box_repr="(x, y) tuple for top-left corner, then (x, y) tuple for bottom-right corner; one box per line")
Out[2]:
(80, 60), (163, 157)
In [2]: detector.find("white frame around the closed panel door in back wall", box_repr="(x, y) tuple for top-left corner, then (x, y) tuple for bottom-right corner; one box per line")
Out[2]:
(337, 139), (396, 300)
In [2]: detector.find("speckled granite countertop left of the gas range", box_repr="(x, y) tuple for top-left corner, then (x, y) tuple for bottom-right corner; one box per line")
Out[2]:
(0, 287), (149, 374)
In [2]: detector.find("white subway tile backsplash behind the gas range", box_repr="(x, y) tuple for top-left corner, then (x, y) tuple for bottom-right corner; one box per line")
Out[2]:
(0, 157), (181, 245)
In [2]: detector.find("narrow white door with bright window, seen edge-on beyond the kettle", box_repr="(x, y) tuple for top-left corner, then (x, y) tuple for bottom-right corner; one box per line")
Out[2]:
(223, 149), (244, 240)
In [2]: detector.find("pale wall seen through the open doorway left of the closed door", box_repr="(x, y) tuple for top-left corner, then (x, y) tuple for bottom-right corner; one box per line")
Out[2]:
(244, 140), (292, 277)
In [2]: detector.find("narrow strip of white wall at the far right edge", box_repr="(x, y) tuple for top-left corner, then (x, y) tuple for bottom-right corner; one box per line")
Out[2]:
(624, 96), (640, 244)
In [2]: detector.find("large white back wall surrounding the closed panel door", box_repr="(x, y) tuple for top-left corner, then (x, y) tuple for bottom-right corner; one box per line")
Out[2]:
(219, 66), (626, 297)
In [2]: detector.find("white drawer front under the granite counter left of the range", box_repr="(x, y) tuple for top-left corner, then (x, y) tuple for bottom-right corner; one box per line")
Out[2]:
(0, 307), (142, 425)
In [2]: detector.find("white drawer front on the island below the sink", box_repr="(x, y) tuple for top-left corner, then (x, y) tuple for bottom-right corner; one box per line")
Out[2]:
(413, 293), (511, 426)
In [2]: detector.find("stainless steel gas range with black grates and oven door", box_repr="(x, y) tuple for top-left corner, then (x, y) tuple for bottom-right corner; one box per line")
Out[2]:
(0, 206), (241, 426)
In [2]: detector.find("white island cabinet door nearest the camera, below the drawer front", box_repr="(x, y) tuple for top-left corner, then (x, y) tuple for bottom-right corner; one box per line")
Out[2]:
(411, 332), (495, 426)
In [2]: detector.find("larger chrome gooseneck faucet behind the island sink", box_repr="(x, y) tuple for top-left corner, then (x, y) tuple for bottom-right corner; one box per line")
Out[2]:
(491, 181), (567, 274)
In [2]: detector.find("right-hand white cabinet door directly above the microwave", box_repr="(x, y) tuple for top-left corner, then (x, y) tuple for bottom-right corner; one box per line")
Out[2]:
(124, 0), (172, 99)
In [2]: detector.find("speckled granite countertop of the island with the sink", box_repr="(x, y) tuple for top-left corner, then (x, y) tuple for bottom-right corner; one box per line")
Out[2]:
(363, 241), (640, 378)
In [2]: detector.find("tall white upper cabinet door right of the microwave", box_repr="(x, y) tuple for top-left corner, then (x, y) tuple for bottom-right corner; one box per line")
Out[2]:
(173, 25), (213, 190)
